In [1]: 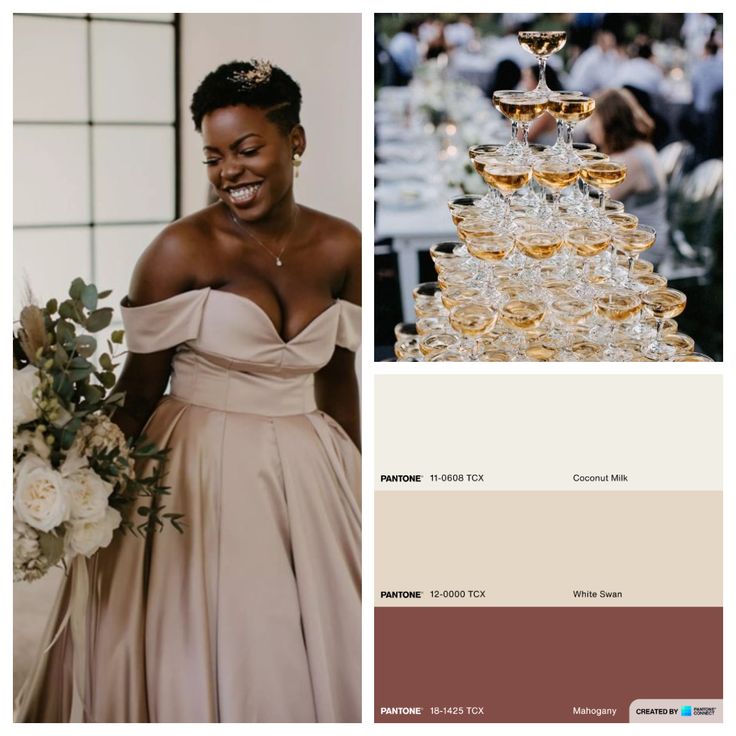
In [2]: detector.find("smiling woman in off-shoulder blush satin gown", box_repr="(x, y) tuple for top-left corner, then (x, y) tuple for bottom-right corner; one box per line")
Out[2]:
(17, 61), (360, 722)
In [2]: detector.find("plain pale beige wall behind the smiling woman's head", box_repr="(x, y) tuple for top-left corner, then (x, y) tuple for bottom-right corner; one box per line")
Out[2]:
(181, 13), (361, 226)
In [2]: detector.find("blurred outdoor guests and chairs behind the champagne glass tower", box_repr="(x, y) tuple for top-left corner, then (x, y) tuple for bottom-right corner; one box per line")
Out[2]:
(375, 13), (723, 359)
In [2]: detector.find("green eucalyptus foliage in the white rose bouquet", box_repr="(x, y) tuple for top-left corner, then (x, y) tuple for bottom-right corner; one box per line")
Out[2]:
(13, 278), (183, 536)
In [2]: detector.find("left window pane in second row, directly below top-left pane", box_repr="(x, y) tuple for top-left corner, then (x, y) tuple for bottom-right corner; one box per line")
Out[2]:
(13, 125), (90, 225)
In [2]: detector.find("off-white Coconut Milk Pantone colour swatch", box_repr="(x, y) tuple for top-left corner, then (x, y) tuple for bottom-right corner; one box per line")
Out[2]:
(375, 375), (723, 492)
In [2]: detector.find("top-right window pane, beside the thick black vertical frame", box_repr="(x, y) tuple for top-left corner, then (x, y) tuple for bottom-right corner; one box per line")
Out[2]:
(92, 22), (175, 123)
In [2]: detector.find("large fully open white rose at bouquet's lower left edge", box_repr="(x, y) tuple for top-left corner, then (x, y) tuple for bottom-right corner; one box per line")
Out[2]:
(13, 455), (69, 532)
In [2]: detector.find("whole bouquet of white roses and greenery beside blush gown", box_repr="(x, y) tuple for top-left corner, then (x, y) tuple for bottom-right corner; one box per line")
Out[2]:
(13, 278), (182, 581)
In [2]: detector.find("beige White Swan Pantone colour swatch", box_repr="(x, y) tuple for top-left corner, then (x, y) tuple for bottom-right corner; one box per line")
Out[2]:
(375, 491), (723, 606)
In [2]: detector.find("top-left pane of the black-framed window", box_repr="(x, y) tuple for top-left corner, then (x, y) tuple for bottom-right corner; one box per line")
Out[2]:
(13, 16), (89, 121)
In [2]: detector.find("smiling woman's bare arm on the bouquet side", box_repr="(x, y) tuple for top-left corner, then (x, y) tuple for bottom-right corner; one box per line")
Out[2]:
(113, 223), (200, 437)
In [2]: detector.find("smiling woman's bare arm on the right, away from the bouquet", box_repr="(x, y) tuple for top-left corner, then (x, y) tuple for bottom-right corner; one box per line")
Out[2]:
(314, 228), (361, 448)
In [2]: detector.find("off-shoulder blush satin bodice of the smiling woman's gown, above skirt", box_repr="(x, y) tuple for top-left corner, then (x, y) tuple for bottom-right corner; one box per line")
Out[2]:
(122, 287), (361, 416)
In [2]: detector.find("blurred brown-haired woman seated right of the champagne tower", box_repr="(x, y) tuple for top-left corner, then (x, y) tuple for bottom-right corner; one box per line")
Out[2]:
(586, 89), (669, 265)
